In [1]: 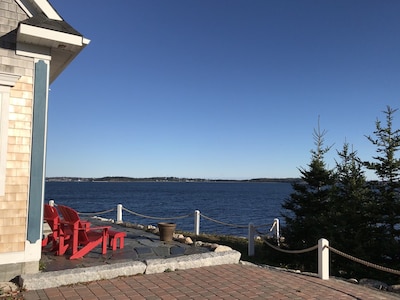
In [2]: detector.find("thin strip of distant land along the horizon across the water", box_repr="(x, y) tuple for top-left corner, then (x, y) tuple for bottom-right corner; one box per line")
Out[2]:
(46, 176), (301, 183)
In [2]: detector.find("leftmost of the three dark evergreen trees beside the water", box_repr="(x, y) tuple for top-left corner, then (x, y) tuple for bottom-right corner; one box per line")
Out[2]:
(282, 124), (334, 249)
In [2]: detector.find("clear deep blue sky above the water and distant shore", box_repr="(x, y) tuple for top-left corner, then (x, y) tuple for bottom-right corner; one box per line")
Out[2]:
(46, 0), (400, 179)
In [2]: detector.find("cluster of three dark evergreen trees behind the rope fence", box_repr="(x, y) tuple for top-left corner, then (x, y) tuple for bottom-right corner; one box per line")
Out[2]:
(282, 106), (400, 283)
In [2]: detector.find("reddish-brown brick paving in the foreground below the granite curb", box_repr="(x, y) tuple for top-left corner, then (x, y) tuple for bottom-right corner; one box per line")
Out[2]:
(23, 264), (400, 300)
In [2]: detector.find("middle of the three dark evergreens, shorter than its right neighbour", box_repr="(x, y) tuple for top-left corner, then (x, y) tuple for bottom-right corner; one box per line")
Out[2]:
(327, 143), (382, 276)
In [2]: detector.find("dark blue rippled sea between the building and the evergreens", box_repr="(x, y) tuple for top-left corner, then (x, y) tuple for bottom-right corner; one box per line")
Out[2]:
(45, 182), (292, 236)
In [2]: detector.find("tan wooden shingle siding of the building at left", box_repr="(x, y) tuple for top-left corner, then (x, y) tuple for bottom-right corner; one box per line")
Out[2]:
(0, 0), (34, 253)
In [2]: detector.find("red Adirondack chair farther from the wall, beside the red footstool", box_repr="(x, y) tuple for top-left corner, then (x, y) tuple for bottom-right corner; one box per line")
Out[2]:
(57, 205), (110, 259)
